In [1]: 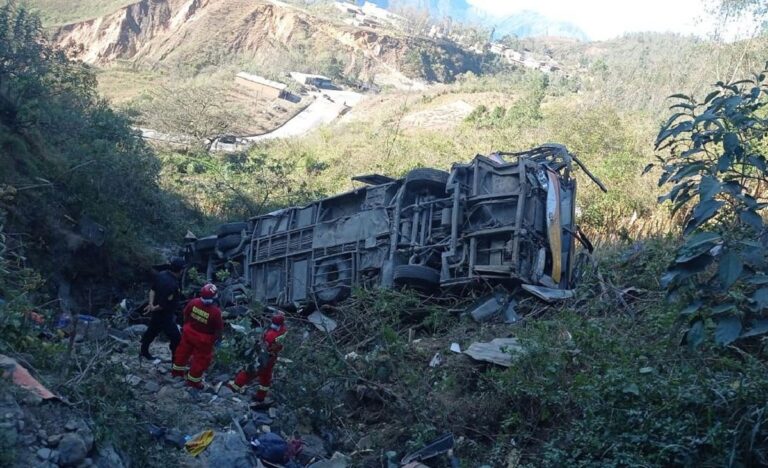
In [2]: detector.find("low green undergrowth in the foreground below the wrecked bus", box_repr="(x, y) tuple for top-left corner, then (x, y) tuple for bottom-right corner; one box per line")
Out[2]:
(277, 238), (768, 467)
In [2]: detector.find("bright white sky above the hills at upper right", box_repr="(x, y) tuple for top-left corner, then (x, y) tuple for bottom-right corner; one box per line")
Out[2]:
(467, 0), (754, 40)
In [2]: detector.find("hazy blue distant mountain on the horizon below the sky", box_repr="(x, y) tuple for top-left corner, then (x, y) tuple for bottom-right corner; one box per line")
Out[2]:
(357, 0), (588, 41)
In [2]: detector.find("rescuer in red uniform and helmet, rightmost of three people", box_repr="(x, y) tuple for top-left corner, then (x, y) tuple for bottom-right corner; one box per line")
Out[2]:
(228, 311), (288, 405)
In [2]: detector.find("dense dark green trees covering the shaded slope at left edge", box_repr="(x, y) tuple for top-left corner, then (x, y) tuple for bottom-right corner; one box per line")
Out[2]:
(0, 3), (190, 276)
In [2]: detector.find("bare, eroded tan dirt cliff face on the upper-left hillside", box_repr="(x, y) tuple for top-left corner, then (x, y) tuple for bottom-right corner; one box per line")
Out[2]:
(53, 0), (484, 82)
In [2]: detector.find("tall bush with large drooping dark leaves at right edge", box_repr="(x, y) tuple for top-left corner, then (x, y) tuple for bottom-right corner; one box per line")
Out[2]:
(649, 66), (768, 347)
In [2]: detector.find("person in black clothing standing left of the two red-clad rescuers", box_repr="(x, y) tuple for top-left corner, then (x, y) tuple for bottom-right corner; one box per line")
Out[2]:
(139, 258), (184, 360)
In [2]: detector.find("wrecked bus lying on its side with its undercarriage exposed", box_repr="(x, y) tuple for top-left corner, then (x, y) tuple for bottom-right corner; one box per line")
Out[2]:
(186, 144), (602, 304)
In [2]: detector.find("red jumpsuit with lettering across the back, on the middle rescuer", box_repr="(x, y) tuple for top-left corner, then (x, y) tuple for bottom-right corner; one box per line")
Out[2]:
(171, 297), (224, 388)
